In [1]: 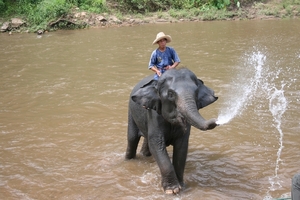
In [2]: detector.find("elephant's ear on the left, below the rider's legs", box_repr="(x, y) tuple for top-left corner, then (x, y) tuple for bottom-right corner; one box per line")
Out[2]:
(131, 80), (161, 114)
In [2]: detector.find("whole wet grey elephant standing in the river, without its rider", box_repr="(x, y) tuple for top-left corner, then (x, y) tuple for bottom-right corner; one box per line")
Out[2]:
(125, 68), (218, 194)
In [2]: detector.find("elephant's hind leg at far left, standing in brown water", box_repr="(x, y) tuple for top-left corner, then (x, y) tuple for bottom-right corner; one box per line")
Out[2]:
(125, 113), (141, 159)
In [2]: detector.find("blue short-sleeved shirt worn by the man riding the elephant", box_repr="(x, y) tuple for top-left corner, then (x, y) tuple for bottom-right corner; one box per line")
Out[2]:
(148, 46), (180, 80)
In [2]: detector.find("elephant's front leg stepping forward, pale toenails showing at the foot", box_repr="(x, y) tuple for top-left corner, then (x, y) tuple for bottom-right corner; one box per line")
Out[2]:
(148, 133), (181, 194)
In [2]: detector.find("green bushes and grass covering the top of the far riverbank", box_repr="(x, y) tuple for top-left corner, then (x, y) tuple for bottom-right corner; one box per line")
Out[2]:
(0, 0), (300, 32)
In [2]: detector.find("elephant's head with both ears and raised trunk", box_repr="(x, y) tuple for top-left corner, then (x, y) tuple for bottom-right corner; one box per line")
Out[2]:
(131, 68), (218, 130)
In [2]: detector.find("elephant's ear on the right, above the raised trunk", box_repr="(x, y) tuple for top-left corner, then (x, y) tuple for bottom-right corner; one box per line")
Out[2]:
(197, 79), (218, 110)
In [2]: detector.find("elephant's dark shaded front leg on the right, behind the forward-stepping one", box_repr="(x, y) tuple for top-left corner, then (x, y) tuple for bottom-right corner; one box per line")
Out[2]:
(173, 130), (190, 187)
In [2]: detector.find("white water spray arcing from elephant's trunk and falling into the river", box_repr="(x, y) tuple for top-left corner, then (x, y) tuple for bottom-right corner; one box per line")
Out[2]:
(216, 51), (288, 200)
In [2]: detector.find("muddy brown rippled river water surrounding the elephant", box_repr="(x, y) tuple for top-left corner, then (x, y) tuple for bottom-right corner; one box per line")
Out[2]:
(0, 20), (300, 200)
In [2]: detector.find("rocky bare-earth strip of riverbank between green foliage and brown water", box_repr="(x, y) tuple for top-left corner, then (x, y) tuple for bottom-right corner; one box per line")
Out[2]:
(0, 0), (300, 34)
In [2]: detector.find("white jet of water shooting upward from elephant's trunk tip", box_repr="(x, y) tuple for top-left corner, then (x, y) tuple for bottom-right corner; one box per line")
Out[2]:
(216, 52), (266, 125)
